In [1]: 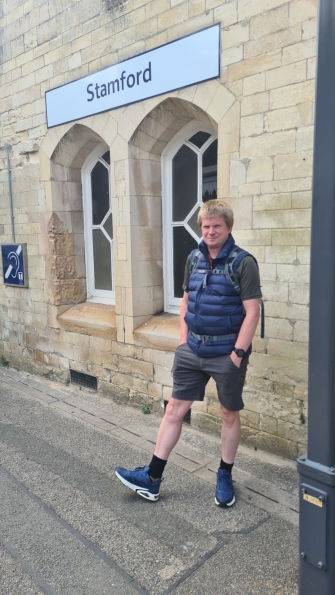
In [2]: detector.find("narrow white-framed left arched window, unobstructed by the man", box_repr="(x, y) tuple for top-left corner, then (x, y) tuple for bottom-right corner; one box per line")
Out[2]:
(82, 143), (115, 304)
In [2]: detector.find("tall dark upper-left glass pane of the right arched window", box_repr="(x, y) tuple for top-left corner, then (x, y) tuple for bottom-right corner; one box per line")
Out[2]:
(172, 145), (198, 221)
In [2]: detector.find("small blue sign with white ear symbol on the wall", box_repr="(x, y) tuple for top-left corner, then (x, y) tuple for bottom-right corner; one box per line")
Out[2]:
(1, 244), (28, 287)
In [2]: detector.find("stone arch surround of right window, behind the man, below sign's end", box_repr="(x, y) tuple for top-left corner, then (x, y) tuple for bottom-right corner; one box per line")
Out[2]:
(111, 97), (222, 340)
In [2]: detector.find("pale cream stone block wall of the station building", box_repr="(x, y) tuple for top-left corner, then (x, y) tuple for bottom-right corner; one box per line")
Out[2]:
(0, 0), (316, 457)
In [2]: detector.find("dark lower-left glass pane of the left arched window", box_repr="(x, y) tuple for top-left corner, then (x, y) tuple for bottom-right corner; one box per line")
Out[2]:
(92, 229), (113, 291)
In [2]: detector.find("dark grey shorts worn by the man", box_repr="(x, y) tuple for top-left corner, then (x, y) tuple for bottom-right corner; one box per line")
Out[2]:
(172, 343), (249, 411)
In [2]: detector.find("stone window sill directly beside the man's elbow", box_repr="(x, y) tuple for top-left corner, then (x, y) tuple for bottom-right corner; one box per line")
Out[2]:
(134, 314), (180, 351)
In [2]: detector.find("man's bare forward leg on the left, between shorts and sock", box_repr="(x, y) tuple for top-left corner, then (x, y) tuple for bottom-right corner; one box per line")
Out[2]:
(154, 397), (193, 461)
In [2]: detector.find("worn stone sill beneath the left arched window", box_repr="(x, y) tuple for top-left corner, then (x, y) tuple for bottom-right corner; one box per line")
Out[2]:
(58, 302), (116, 339)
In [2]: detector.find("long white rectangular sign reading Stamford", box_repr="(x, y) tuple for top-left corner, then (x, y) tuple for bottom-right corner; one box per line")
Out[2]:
(45, 24), (220, 128)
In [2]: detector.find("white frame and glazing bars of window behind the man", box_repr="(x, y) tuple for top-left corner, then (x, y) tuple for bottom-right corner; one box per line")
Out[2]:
(161, 120), (217, 314)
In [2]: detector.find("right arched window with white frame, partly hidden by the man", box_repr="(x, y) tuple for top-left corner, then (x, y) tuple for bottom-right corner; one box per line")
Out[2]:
(162, 121), (218, 312)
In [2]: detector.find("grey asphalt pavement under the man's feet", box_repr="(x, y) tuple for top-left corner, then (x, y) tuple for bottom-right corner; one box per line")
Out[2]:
(0, 369), (298, 595)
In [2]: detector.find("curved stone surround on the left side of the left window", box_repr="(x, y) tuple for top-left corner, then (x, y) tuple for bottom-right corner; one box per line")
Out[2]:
(42, 124), (108, 320)
